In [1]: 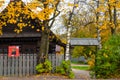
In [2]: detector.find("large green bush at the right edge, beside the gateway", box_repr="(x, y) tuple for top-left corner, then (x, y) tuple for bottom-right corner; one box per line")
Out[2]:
(93, 35), (120, 78)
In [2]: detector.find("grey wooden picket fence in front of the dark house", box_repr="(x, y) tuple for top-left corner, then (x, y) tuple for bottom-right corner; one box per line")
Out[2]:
(0, 54), (64, 76)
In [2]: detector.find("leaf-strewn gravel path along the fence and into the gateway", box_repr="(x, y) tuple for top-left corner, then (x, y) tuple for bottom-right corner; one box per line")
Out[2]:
(0, 69), (90, 80)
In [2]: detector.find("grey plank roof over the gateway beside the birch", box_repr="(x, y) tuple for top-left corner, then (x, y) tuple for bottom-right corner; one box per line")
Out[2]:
(70, 38), (99, 46)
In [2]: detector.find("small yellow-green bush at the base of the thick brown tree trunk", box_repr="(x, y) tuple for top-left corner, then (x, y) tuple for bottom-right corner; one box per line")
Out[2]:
(36, 59), (52, 73)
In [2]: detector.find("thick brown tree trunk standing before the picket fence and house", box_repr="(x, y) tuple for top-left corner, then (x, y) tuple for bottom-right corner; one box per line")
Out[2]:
(37, 0), (50, 63)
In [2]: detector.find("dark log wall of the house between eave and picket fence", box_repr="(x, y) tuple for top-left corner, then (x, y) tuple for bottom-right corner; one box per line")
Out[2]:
(0, 38), (40, 54)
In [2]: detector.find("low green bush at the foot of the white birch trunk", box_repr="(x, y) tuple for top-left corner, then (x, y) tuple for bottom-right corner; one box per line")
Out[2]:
(56, 60), (75, 79)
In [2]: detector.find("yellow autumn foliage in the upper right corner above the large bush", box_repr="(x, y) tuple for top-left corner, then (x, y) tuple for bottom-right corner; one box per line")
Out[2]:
(95, 0), (120, 42)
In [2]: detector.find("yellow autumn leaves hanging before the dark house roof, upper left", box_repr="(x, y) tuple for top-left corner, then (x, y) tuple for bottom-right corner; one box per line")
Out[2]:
(0, 0), (59, 35)
